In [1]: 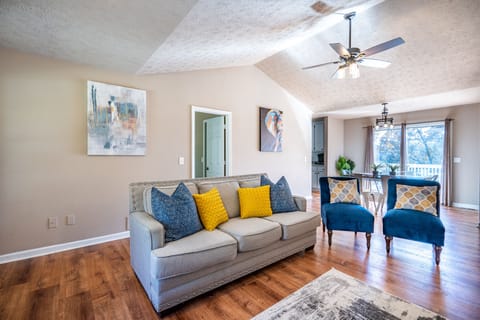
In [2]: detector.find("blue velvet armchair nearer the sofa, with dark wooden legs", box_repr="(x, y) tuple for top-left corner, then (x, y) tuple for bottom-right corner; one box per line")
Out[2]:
(320, 177), (375, 249)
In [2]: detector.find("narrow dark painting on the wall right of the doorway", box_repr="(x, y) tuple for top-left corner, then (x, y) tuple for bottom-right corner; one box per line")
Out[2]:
(259, 107), (283, 152)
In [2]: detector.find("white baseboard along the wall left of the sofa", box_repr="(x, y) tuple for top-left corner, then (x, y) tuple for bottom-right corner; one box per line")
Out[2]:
(0, 231), (130, 264)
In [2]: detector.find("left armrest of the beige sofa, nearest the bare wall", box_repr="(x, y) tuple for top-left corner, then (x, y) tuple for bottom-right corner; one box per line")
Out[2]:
(129, 211), (165, 297)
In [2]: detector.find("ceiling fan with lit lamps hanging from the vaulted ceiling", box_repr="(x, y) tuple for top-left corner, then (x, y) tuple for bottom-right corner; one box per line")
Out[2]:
(302, 12), (405, 79)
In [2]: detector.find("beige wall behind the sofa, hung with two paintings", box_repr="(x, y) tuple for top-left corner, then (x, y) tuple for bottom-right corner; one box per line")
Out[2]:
(0, 48), (311, 254)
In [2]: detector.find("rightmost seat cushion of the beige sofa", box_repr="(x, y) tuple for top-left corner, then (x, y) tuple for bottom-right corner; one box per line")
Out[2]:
(264, 211), (320, 240)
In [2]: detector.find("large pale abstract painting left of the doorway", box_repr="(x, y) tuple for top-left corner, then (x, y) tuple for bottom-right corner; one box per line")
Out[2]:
(87, 81), (147, 156)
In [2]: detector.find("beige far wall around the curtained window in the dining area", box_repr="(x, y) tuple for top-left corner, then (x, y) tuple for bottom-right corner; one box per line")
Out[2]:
(345, 104), (480, 205)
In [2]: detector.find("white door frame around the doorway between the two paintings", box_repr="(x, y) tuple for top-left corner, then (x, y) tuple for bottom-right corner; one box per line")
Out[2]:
(190, 105), (232, 178)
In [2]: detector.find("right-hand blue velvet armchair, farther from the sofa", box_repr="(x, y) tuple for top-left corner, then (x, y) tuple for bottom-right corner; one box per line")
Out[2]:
(383, 179), (445, 265)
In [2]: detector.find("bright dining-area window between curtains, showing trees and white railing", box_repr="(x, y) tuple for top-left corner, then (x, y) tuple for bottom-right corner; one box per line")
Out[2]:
(373, 122), (445, 181)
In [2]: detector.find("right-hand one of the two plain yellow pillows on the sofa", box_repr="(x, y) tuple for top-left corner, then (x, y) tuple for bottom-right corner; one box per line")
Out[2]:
(238, 185), (272, 219)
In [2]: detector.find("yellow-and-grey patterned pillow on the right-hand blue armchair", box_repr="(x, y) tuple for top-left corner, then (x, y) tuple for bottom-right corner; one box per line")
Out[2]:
(394, 184), (438, 216)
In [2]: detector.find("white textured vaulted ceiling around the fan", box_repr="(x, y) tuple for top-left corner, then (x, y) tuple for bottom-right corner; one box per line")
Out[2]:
(0, 0), (480, 118)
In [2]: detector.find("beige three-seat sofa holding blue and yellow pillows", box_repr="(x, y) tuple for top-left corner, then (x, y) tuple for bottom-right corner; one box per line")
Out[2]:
(129, 174), (320, 312)
